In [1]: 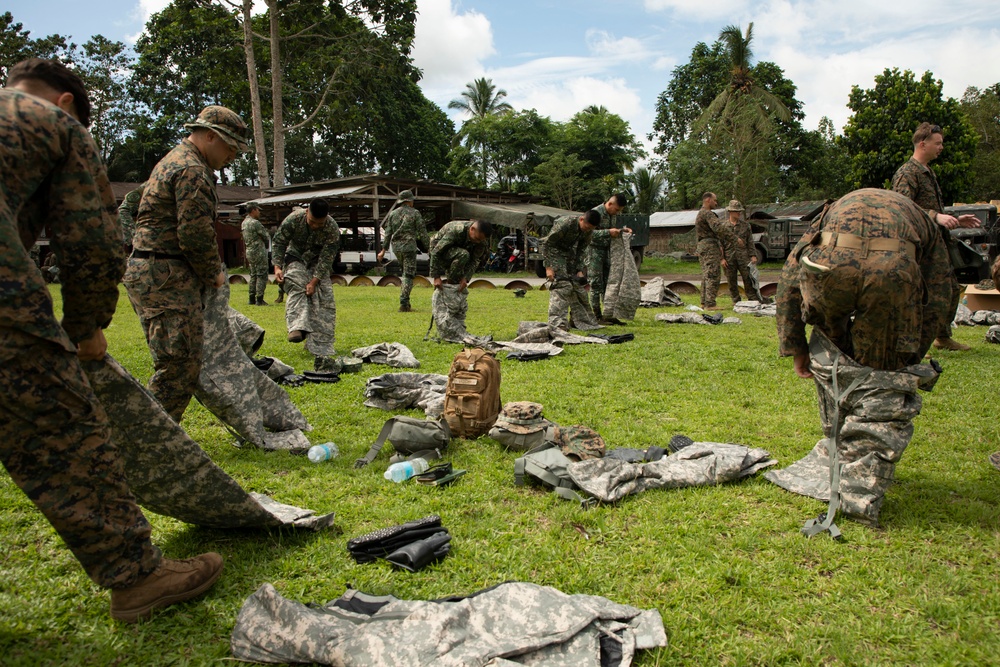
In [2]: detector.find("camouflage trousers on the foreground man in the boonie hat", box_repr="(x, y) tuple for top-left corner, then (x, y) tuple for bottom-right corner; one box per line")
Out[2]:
(123, 257), (205, 423)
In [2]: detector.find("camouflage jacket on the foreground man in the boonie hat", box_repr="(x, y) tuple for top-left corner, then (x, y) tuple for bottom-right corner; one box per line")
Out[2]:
(132, 139), (222, 285)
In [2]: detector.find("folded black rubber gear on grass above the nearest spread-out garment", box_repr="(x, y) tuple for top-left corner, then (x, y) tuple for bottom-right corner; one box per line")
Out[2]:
(347, 514), (451, 572)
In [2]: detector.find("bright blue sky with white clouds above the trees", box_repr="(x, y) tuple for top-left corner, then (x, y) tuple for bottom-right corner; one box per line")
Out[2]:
(10, 0), (1000, 155)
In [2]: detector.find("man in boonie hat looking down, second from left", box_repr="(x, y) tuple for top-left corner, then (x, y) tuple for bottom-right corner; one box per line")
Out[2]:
(124, 106), (247, 422)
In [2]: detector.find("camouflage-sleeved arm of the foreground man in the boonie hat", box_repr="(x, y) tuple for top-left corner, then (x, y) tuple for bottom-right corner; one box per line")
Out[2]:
(174, 167), (222, 285)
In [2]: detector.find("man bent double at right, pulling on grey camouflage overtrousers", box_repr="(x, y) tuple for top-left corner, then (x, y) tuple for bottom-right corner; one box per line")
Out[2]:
(768, 189), (951, 524)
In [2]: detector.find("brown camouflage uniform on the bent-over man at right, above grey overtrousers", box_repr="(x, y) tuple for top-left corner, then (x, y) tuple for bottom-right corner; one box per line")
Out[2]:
(777, 189), (951, 370)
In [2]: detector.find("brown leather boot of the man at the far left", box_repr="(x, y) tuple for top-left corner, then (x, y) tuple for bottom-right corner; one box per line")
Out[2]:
(111, 552), (222, 623)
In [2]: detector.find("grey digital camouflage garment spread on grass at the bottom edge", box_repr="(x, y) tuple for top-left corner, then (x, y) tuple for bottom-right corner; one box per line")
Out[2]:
(230, 582), (667, 667)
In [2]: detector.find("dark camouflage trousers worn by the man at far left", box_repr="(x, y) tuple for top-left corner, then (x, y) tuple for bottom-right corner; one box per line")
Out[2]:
(0, 328), (160, 588)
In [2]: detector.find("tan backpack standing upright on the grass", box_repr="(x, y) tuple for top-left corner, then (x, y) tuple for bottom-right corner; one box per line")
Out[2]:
(442, 347), (501, 438)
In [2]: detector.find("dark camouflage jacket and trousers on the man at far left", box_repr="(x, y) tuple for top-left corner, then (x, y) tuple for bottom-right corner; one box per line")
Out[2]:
(0, 90), (160, 588)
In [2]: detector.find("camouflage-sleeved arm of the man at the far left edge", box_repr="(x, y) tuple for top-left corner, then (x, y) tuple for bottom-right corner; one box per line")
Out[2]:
(48, 126), (125, 343)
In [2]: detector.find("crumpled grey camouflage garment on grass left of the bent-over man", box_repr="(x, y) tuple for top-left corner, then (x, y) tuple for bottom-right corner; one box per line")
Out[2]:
(567, 442), (778, 503)
